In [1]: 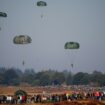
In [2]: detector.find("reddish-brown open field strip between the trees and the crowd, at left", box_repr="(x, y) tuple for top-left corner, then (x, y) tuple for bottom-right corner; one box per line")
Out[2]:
(0, 86), (67, 96)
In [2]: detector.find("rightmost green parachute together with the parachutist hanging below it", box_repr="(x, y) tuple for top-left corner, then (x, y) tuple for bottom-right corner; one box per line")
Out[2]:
(64, 42), (80, 68)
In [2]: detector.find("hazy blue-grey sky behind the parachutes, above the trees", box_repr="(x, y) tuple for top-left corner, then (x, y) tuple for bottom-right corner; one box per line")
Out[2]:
(0, 0), (105, 72)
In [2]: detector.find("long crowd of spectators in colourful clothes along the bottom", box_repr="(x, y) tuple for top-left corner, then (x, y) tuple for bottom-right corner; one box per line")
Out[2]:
(0, 85), (105, 104)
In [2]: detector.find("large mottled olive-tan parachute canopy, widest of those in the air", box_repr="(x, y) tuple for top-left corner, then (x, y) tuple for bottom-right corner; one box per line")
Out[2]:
(13, 35), (32, 44)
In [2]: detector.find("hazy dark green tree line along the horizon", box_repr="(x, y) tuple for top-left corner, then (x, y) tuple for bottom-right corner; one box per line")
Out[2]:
(0, 68), (105, 86)
